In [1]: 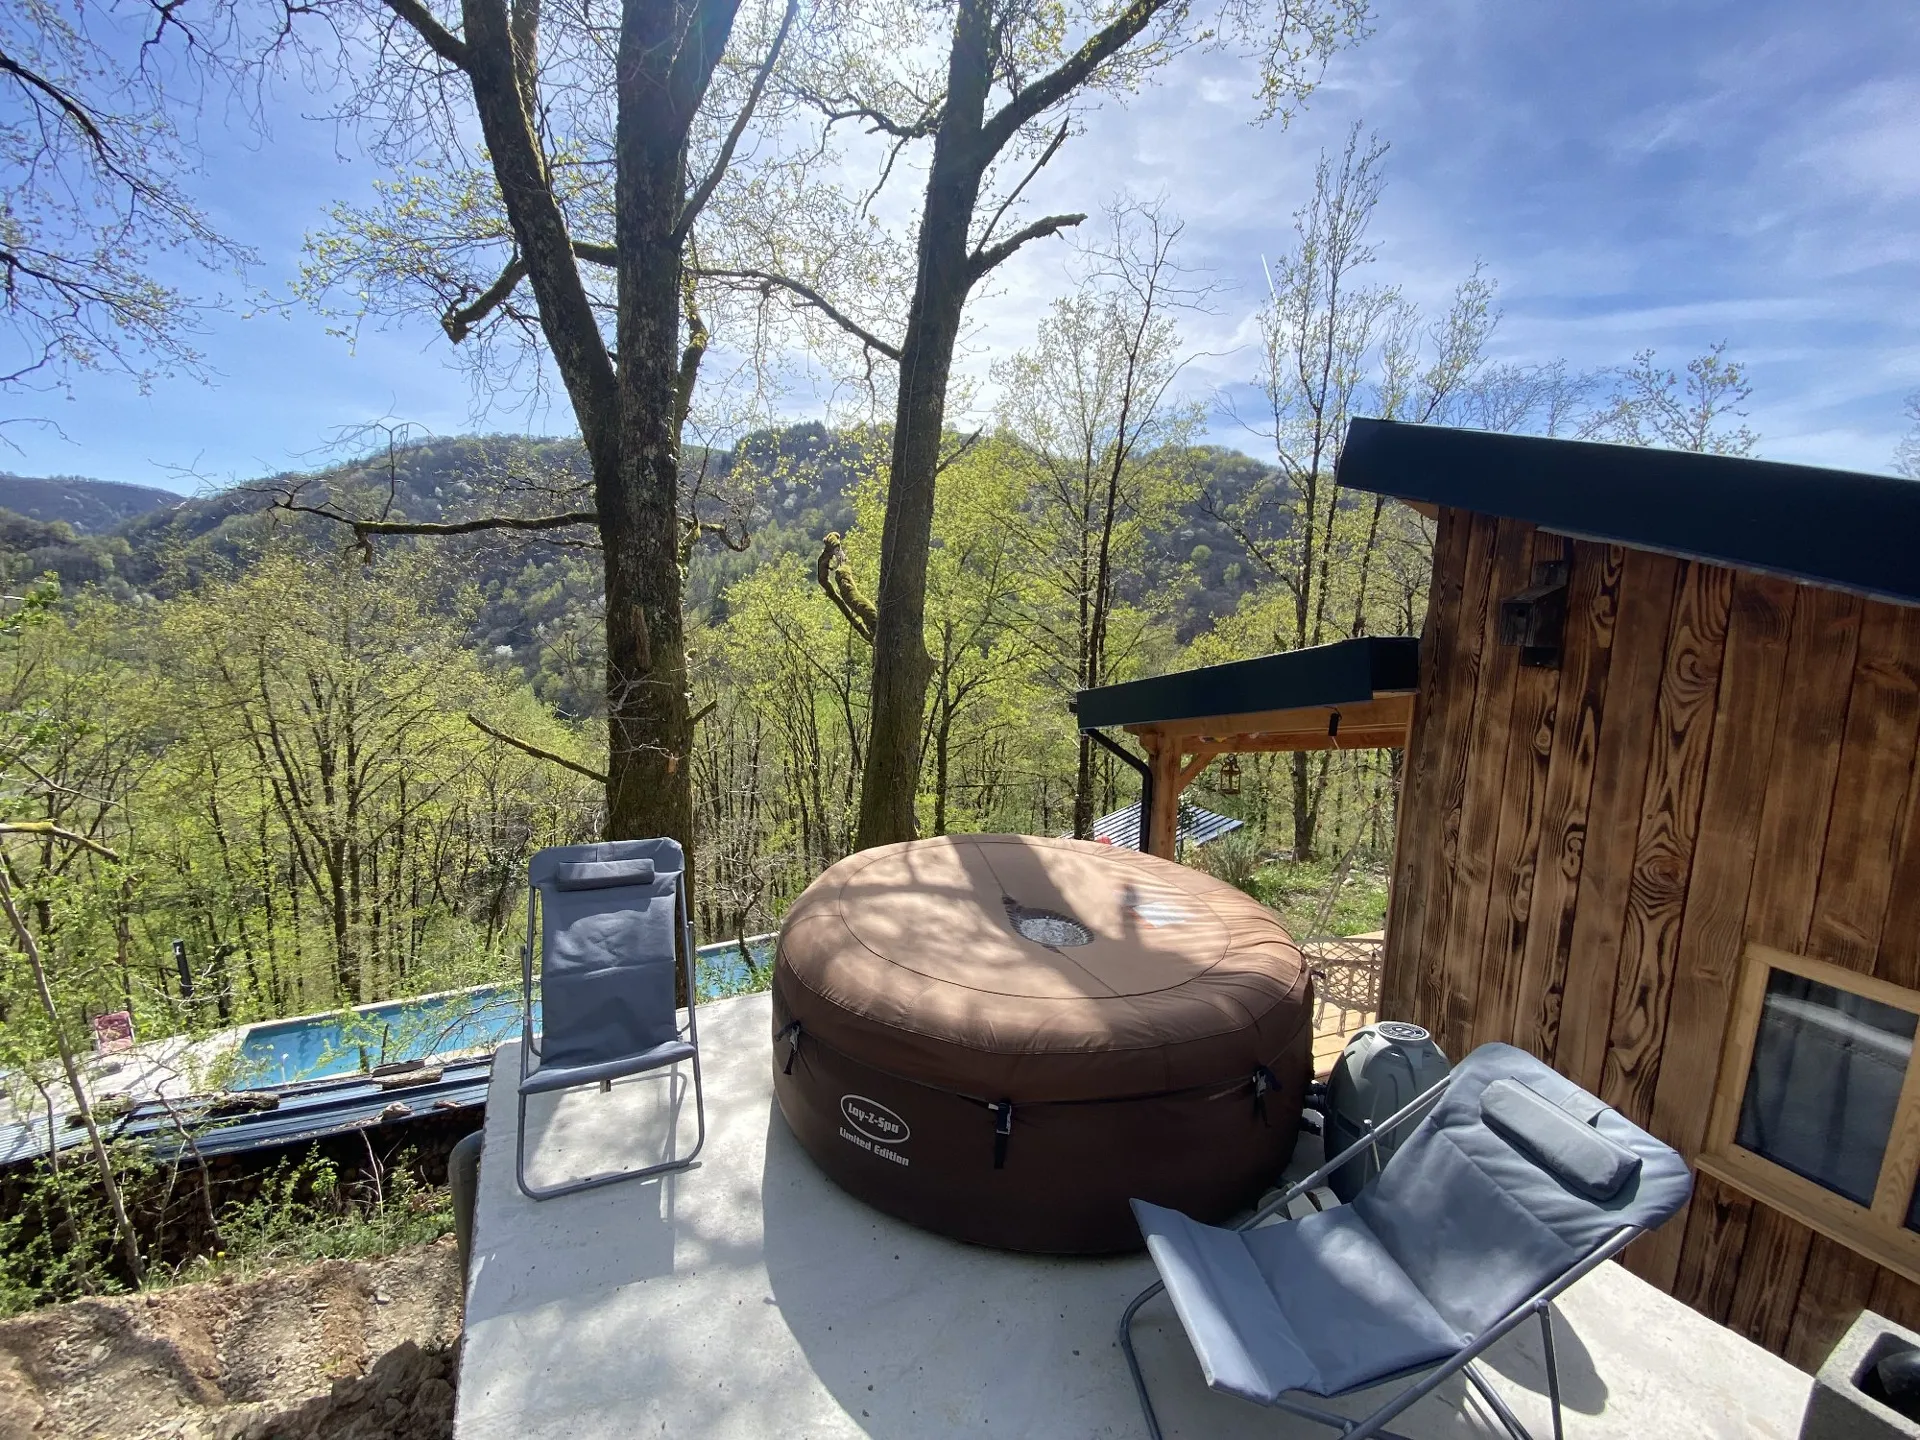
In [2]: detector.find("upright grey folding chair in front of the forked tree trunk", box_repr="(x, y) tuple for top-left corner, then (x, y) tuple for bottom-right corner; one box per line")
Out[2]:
(515, 839), (707, 1200)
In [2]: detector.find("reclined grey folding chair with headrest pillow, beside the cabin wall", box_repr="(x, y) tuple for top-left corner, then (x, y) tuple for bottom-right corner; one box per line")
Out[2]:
(1119, 1044), (1693, 1440)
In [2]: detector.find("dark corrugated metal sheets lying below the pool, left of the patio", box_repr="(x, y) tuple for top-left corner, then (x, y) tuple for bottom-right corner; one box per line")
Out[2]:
(0, 1056), (493, 1165)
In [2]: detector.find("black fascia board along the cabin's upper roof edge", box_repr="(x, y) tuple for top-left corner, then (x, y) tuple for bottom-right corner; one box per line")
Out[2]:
(1336, 420), (1920, 605)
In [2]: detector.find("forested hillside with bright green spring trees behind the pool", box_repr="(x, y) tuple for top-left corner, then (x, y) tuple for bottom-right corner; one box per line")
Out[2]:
(0, 424), (1417, 1068)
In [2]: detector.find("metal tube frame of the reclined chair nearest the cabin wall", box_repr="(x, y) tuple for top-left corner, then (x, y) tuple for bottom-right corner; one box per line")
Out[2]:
(1119, 1075), (1642, 1440)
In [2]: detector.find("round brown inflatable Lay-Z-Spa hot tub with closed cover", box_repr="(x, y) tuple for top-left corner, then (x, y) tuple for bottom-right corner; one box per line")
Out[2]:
(774, 835), (1313, 1254)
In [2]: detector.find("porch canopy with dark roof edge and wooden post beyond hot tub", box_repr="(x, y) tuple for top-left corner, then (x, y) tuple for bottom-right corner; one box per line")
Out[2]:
(1073, 636), (1419, 860)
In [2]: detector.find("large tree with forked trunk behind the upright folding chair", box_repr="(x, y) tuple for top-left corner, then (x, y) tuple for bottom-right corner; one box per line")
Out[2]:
(286, 0), (797, 867)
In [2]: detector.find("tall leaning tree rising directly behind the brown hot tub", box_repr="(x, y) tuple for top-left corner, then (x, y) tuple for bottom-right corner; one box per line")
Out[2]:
(735, 0), (1367, 847)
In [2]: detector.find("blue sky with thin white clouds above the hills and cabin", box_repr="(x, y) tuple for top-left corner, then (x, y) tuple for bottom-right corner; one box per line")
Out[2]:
(0, 0), (1920, 490)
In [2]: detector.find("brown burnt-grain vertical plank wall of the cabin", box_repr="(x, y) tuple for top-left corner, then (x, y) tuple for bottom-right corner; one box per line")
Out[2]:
(1380, 511), (1920, 1369)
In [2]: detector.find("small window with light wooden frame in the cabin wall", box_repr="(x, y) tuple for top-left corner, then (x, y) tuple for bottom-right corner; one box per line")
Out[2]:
(1695, 945), (1920, 1281)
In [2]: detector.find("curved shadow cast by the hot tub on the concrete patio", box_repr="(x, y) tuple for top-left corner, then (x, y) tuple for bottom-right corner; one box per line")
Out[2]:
(762, 1104), (1607, 1440)
